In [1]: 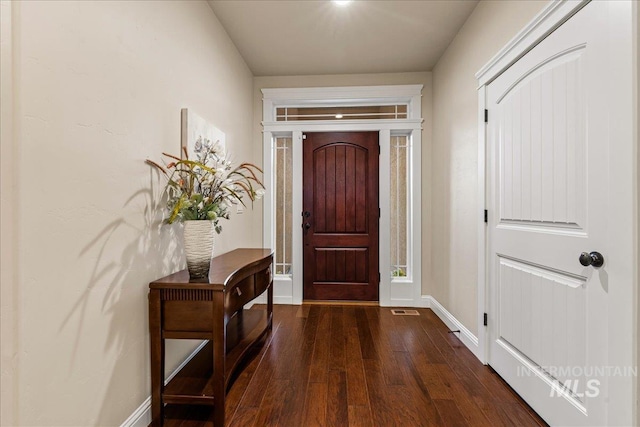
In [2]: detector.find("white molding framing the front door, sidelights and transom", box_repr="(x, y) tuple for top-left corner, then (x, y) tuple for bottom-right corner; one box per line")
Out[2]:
(262, 85), (423, 307)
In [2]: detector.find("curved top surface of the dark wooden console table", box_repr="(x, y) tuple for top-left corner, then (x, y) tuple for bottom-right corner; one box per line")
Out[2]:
(149, 248), (273, 289)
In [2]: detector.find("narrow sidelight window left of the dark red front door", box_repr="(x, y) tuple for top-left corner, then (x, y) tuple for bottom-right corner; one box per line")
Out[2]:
(274, 136), (293, 275)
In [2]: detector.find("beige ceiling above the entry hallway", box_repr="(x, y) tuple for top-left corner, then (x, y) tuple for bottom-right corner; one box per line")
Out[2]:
(209, 0), (477, 76)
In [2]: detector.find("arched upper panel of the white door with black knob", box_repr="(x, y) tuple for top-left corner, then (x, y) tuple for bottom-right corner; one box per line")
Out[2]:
(496, 46), (586, 229)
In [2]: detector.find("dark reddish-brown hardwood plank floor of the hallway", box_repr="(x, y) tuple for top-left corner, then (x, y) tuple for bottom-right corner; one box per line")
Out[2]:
(159, 305), (546, 427)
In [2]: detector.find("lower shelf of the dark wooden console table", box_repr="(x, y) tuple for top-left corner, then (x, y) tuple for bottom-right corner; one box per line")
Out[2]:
(162, 310), (272, 406)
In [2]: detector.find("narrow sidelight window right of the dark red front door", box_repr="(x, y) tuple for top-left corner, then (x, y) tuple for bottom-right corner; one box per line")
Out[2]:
(390, 135), (410, 280)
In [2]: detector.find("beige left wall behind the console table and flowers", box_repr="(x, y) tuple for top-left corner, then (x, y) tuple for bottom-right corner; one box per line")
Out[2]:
(0, 1), (262, 426)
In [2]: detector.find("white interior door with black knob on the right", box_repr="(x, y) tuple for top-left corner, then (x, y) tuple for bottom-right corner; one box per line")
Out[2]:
(487, 2), (632, 426)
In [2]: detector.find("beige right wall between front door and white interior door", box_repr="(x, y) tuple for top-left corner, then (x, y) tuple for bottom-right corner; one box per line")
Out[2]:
(431, 1), (547, 333)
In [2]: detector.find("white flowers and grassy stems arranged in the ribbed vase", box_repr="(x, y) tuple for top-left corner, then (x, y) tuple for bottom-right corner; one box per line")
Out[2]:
(146, 137), (264, 234)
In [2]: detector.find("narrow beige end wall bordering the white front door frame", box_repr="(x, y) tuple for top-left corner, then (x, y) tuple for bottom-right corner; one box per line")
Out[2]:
(253, 72), (433, 295)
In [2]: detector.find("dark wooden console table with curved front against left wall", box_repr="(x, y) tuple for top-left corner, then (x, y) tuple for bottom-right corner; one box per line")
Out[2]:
(149, 249), (273, 427)
